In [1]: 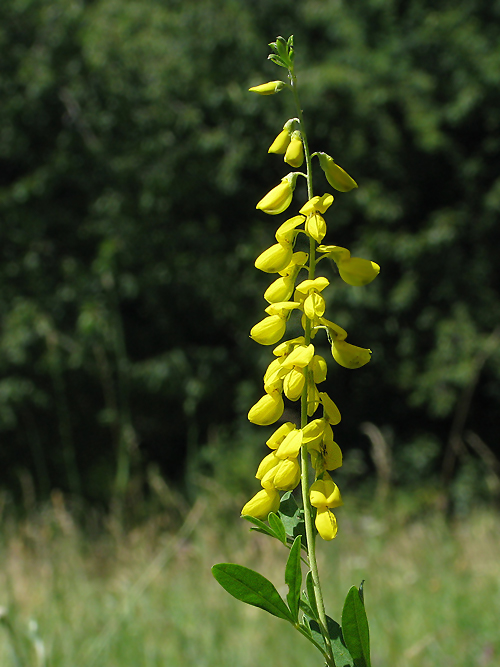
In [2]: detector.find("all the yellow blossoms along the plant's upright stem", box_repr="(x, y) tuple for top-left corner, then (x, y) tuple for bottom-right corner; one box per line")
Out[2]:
(242, 81), (380, 540)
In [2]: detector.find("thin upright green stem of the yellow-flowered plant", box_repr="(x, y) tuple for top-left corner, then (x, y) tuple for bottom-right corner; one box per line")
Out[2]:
(290, 71), (336, 667)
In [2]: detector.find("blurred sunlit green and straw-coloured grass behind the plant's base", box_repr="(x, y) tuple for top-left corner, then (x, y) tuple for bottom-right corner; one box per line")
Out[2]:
(0, 490), (500, 667)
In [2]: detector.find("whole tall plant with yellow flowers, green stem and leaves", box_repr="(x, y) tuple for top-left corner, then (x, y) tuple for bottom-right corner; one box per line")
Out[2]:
(213, 36), (380, 667)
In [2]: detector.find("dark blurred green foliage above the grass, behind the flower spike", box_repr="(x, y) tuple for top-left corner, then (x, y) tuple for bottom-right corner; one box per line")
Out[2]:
(0, 0), (500, 501)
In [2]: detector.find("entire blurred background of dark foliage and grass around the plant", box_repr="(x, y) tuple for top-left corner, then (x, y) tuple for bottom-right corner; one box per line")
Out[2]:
(0, 0), (500, 667)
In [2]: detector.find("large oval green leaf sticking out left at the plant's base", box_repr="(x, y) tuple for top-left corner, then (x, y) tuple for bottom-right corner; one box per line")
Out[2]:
(212, 563), (294, 623)
